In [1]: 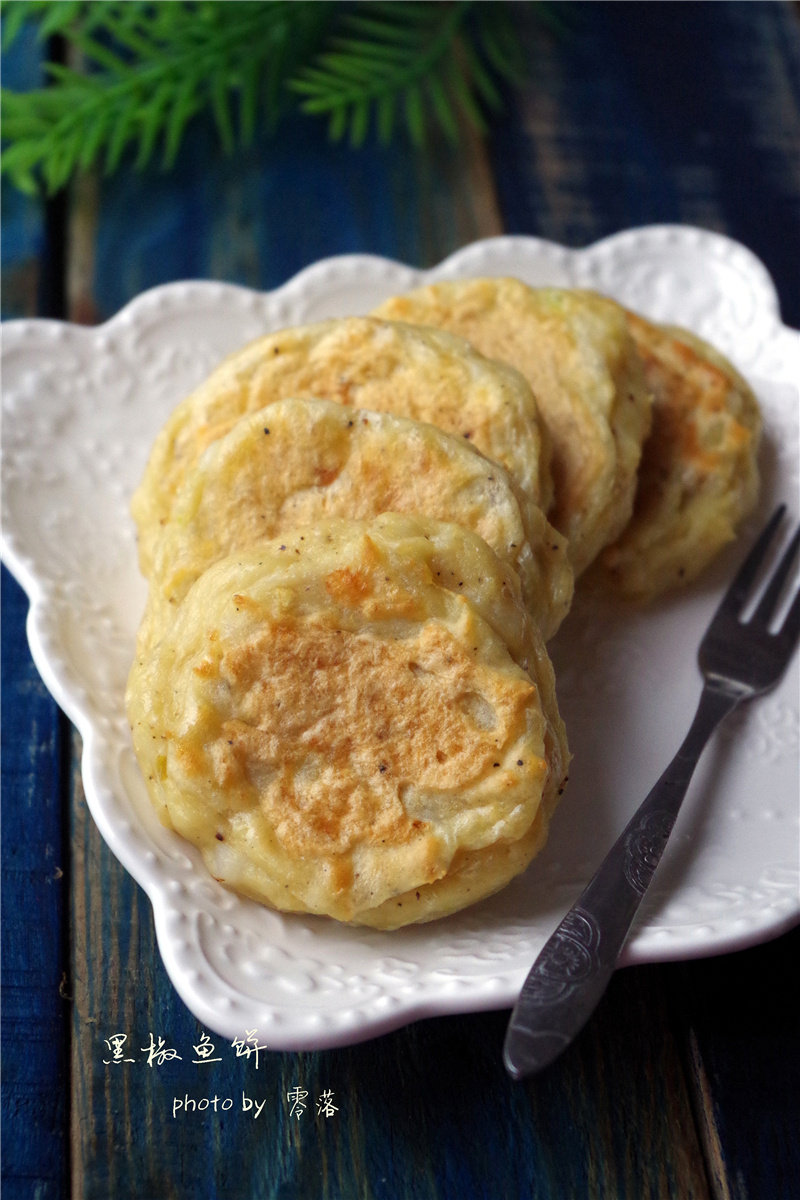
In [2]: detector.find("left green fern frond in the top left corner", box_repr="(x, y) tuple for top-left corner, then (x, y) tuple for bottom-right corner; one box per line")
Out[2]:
(0, 0), (329, 192)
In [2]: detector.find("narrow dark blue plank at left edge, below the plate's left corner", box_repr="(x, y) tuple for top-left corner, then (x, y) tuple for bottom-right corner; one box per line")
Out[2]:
(2, 568), (70, 1200)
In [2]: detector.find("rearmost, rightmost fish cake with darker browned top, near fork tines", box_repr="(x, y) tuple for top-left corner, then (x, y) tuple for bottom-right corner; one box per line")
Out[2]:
(595, 313), (762, 601)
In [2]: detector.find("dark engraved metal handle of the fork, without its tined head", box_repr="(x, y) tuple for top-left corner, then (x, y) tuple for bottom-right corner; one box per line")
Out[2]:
(503, 682), (744, 1079)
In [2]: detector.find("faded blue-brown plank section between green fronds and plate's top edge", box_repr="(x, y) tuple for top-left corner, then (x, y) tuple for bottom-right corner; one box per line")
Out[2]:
(68, 104), (501, 322)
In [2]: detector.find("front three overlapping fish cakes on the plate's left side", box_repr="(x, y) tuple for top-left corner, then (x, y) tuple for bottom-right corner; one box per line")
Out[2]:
(127, 318), (573, 929)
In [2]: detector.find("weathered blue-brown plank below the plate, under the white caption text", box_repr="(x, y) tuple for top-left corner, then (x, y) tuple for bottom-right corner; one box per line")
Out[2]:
(73, 816), (709, 1200)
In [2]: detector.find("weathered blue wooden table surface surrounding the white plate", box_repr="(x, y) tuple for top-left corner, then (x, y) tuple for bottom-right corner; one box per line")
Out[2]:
(2, 2), (800, 1200)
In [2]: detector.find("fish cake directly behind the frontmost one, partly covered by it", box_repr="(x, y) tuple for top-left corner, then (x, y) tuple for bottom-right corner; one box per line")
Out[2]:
(143, 398), (572, 644)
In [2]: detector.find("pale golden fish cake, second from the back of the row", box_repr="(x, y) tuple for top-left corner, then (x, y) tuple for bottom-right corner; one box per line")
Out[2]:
(375, 278), (651, 576)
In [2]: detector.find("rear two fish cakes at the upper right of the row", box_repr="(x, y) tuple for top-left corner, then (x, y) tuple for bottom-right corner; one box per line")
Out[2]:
(375, 278), (762, 602)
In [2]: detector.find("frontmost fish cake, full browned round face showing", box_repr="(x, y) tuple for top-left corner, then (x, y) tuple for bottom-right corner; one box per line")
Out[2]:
(127, 514), (569, 929)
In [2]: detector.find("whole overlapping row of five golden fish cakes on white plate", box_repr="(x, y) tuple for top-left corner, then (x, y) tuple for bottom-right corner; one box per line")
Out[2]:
(127, 288), (760, 929)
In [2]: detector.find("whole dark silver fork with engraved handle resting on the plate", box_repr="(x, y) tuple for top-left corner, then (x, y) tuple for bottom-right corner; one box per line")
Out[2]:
(503, 505), (800, 1079)
